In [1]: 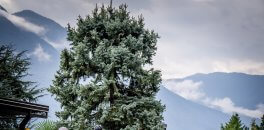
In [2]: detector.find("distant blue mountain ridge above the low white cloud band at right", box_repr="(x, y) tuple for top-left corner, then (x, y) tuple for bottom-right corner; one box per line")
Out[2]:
(167, 72), (264, 109)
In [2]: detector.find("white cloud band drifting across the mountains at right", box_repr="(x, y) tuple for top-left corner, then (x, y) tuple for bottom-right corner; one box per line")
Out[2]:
(163, 80), (264, 118)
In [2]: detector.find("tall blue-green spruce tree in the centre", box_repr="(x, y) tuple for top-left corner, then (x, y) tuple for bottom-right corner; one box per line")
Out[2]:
(49, 5), (165, 130)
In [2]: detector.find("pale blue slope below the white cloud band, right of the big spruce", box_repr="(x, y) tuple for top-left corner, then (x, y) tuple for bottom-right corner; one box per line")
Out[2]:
(157, 87), (229, 130)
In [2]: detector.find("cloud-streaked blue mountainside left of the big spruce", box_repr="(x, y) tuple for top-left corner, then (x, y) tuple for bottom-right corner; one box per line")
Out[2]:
(0, 5), (64, 119)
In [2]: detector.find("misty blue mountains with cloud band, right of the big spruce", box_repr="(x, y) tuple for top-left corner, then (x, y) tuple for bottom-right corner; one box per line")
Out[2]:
(163, 72), (264, 130)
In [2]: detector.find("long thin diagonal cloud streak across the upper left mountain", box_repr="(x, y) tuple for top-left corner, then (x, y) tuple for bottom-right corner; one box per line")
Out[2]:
(0, 10), (45, 35)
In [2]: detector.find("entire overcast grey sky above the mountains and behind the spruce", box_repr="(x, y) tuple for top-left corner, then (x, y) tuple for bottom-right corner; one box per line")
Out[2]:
(0, 0), (264, 79)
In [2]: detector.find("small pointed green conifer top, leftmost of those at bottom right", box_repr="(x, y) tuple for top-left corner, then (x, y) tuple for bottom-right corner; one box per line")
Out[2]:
(221, 114), (248, 130)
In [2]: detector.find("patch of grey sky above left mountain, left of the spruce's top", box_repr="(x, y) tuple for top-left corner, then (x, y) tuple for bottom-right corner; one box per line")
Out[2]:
(0, 0), (95, 27)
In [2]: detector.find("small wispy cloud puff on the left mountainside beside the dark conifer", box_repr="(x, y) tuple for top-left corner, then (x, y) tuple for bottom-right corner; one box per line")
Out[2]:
(32, 44), (51, 62)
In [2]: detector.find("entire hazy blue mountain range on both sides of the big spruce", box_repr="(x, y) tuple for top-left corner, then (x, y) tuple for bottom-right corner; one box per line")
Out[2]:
(0, 5), (264, 130)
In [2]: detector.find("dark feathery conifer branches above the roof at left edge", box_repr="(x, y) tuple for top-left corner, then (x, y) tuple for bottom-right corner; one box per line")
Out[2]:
(0, 45), (43, 129)
